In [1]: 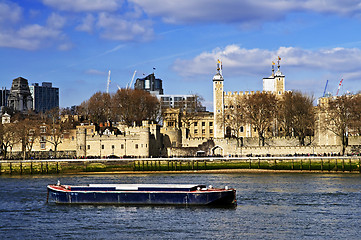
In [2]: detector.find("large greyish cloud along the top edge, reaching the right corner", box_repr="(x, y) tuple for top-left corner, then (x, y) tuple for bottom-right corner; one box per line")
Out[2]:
(129, 0), (361, 25)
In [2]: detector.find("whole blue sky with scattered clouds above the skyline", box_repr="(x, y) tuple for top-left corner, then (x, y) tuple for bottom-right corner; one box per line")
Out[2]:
(0, 0), (361, 111)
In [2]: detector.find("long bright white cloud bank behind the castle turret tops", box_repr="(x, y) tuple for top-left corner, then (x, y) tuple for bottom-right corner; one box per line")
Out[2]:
(173, 45), (361, 79)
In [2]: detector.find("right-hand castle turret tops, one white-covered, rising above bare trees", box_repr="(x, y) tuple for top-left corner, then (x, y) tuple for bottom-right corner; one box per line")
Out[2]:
(263, 57), (285, 95)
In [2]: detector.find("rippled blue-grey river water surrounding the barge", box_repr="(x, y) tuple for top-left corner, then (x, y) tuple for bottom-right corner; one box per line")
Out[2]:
(0, 173), (361, 239)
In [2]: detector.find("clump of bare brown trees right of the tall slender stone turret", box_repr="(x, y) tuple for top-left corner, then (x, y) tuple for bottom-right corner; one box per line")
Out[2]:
(224, 92), (315, 146)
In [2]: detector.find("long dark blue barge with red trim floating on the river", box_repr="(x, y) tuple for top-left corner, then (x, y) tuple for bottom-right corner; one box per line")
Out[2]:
(47, 182), (236, 206)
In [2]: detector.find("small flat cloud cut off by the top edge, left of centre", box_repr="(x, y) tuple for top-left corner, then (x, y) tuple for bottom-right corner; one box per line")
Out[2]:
(43, 0), (123, 12)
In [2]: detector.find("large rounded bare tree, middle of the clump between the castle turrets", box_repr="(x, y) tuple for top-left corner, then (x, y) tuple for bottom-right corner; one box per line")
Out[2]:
(245, 92), (277, 146)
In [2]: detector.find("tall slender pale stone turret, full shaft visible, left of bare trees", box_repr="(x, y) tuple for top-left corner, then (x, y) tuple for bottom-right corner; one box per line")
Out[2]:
(213, 60), (224, 139)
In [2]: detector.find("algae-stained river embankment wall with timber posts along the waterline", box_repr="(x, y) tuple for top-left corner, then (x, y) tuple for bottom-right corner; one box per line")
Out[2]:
(0, 156), (361, 175)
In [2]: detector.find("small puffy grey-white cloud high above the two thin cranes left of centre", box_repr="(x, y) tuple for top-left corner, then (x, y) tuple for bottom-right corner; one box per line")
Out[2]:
(97, 13), (154, 41)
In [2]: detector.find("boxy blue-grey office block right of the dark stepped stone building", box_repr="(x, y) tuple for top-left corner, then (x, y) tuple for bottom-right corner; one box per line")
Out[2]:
(30, 82), (59, 112)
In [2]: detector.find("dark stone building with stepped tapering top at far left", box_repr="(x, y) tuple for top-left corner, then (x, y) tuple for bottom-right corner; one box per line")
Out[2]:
(7, 77), (33, 112)
